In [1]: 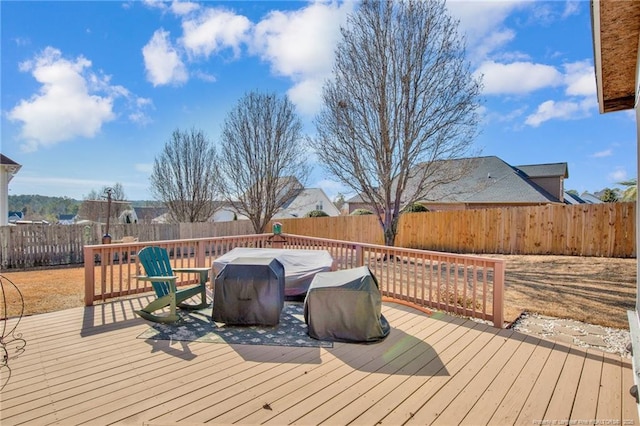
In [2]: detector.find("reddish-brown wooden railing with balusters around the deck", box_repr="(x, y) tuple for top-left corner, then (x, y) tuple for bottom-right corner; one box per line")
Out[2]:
(84, 234), (505, 327)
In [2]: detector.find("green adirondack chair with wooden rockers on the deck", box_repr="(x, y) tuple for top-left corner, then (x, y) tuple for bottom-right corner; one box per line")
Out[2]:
(135, 246), (210, 323)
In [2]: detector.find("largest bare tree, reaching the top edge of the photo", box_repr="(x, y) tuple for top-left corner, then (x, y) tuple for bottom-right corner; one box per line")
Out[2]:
(311, 0), (481, 245)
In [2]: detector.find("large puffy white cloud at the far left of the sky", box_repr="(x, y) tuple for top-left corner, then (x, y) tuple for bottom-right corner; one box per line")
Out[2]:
(8, 47), (116, 151)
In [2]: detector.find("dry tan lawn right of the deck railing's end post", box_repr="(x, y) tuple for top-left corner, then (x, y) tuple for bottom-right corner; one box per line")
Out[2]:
(492, 255), (636, 329)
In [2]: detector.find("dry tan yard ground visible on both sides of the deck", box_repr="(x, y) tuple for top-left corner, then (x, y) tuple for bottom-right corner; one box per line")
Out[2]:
(0, 255), (636, 328)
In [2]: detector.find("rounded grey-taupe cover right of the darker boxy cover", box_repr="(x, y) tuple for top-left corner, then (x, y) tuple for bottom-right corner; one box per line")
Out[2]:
(304, 266), (390, 343)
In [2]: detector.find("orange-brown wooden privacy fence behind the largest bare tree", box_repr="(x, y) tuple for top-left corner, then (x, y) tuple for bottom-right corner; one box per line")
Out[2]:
(280, 203), (636, 258)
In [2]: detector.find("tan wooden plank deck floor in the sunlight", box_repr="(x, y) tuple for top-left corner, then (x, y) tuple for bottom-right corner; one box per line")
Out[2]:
(0, 296), (639, 426)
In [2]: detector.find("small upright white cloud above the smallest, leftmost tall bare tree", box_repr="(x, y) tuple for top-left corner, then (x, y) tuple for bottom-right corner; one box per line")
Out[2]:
(142, 30), (189, 86)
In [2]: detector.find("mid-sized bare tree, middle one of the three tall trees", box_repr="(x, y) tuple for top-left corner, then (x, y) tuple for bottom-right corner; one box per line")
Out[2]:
(219, 92), (309, 233)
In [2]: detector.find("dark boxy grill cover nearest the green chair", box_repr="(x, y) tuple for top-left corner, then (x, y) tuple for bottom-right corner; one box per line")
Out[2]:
(211, 257), (284, 325)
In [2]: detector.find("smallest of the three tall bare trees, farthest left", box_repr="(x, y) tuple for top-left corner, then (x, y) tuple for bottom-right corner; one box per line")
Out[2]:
(150, 129), (218, 222)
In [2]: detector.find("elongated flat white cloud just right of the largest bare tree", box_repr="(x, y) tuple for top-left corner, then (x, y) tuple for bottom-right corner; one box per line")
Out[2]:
(474, 61), (563, 95)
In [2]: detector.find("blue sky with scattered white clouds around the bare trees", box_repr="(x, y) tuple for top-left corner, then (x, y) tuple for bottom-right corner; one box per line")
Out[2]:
(0, 1), (637, 200)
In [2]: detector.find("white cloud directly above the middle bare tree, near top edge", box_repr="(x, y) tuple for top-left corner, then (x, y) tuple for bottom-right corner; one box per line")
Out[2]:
(180, 9), (251, 57)
